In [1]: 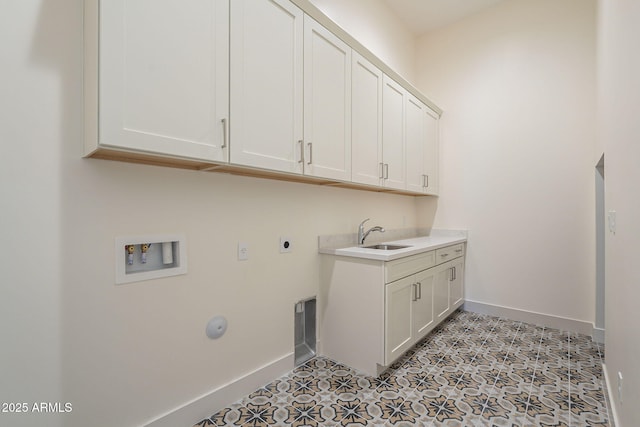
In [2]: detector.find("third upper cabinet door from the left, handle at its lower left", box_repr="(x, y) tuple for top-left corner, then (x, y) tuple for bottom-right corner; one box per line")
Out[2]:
(304, 15), (351, 181)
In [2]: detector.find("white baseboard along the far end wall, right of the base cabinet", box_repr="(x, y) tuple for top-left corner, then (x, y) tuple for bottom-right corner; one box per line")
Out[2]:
(464, 300), (594, 336)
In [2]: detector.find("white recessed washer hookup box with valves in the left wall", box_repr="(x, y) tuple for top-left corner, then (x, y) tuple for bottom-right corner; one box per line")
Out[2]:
(115, 234), (187, 285)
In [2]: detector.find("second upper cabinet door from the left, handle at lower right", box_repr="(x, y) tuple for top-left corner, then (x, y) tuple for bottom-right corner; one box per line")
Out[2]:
(230, 0), (303, 173)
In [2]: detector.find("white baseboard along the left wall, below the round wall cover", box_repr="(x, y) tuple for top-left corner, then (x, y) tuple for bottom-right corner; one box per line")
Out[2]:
(145, 353), (294, 427)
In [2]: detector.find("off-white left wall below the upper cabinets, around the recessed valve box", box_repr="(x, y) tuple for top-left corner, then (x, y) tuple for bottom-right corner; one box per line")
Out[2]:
(0, 0), (418, 427)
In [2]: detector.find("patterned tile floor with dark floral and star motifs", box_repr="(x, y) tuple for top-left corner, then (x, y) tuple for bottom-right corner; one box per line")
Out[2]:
(196, 311), (609, 427)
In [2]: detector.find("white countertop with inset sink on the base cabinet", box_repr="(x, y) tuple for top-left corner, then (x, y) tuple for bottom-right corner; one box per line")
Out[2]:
(318, 230), (467, 261)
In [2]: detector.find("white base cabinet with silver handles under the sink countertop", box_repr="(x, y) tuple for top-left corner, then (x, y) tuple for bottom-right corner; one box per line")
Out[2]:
(321, 243), (465, 376)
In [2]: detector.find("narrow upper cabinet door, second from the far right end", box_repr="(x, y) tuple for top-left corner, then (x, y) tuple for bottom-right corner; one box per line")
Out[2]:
(405, 95), (427, 193)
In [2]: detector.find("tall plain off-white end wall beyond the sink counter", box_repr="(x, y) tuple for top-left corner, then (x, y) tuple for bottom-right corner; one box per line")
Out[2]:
(417, 0), (596, 322)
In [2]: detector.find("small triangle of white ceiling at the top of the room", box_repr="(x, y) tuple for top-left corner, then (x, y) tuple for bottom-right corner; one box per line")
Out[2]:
(384, 0), (504, 35)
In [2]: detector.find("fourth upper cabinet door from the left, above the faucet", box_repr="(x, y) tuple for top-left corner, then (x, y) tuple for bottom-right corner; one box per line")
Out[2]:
(351, 52), (382, 186)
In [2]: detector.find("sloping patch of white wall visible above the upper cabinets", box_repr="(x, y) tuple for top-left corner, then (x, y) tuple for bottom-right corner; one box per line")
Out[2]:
(310, 0), (416, 83)
